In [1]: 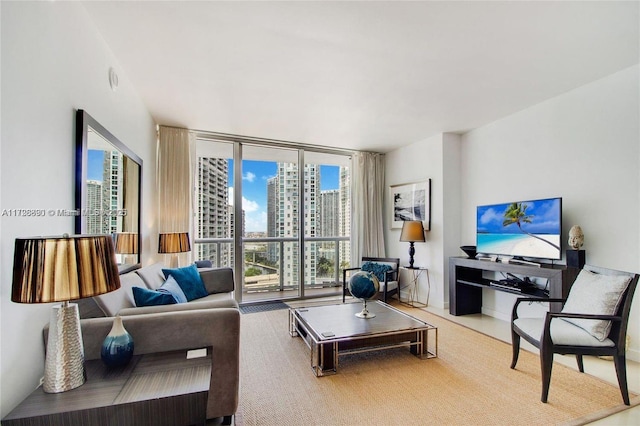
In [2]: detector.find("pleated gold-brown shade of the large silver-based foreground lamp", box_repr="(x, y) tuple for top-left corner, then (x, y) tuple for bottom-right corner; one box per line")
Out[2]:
(11, 235), (120, 303)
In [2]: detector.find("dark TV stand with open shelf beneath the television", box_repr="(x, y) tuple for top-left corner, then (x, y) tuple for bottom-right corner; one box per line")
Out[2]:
(449, 257), (580, 316)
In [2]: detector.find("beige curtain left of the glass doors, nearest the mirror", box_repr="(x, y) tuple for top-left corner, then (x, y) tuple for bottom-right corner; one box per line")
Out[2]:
(156, 126), (195, 258)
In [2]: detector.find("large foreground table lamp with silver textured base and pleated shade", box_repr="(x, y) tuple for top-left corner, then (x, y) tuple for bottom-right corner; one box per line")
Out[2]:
(11, 234), (120, 393)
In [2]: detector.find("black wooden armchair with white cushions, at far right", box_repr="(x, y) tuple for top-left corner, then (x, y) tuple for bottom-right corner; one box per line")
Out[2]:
(511, 265), (638, 405)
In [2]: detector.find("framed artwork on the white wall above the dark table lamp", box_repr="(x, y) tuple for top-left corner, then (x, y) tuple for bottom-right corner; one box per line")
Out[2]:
(389, 179), (431, 231)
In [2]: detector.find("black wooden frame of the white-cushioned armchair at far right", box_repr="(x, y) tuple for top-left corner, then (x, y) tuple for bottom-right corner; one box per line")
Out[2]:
(511, 265), (638, 405)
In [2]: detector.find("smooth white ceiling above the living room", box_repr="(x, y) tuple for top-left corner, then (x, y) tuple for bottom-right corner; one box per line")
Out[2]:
(84, 1), (640, 152)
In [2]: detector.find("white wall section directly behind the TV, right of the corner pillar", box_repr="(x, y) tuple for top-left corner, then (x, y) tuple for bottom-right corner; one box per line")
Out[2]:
(460, 66), (640, 360)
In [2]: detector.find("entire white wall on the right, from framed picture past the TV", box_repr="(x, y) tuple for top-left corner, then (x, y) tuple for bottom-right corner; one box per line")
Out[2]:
(385, 66), (640, 361)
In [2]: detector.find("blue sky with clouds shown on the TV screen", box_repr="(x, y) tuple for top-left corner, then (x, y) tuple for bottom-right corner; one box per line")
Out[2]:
(477, 198), (562, 234)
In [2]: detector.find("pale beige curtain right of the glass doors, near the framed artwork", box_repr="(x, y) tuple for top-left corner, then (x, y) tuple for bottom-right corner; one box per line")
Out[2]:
(351, 152), (385, 265)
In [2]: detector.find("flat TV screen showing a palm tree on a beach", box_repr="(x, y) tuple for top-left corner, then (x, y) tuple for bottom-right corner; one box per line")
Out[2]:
(476, 198), (562, 260)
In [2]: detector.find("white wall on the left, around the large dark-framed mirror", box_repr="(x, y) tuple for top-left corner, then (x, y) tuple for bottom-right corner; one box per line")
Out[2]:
(0, 2), (157, 417)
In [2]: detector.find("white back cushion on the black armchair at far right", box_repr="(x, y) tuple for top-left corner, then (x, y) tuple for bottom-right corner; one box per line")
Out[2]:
(562, 269), (631, 341)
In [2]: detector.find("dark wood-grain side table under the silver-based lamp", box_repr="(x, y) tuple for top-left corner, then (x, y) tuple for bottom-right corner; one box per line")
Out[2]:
(2, 348), (211, 426)
